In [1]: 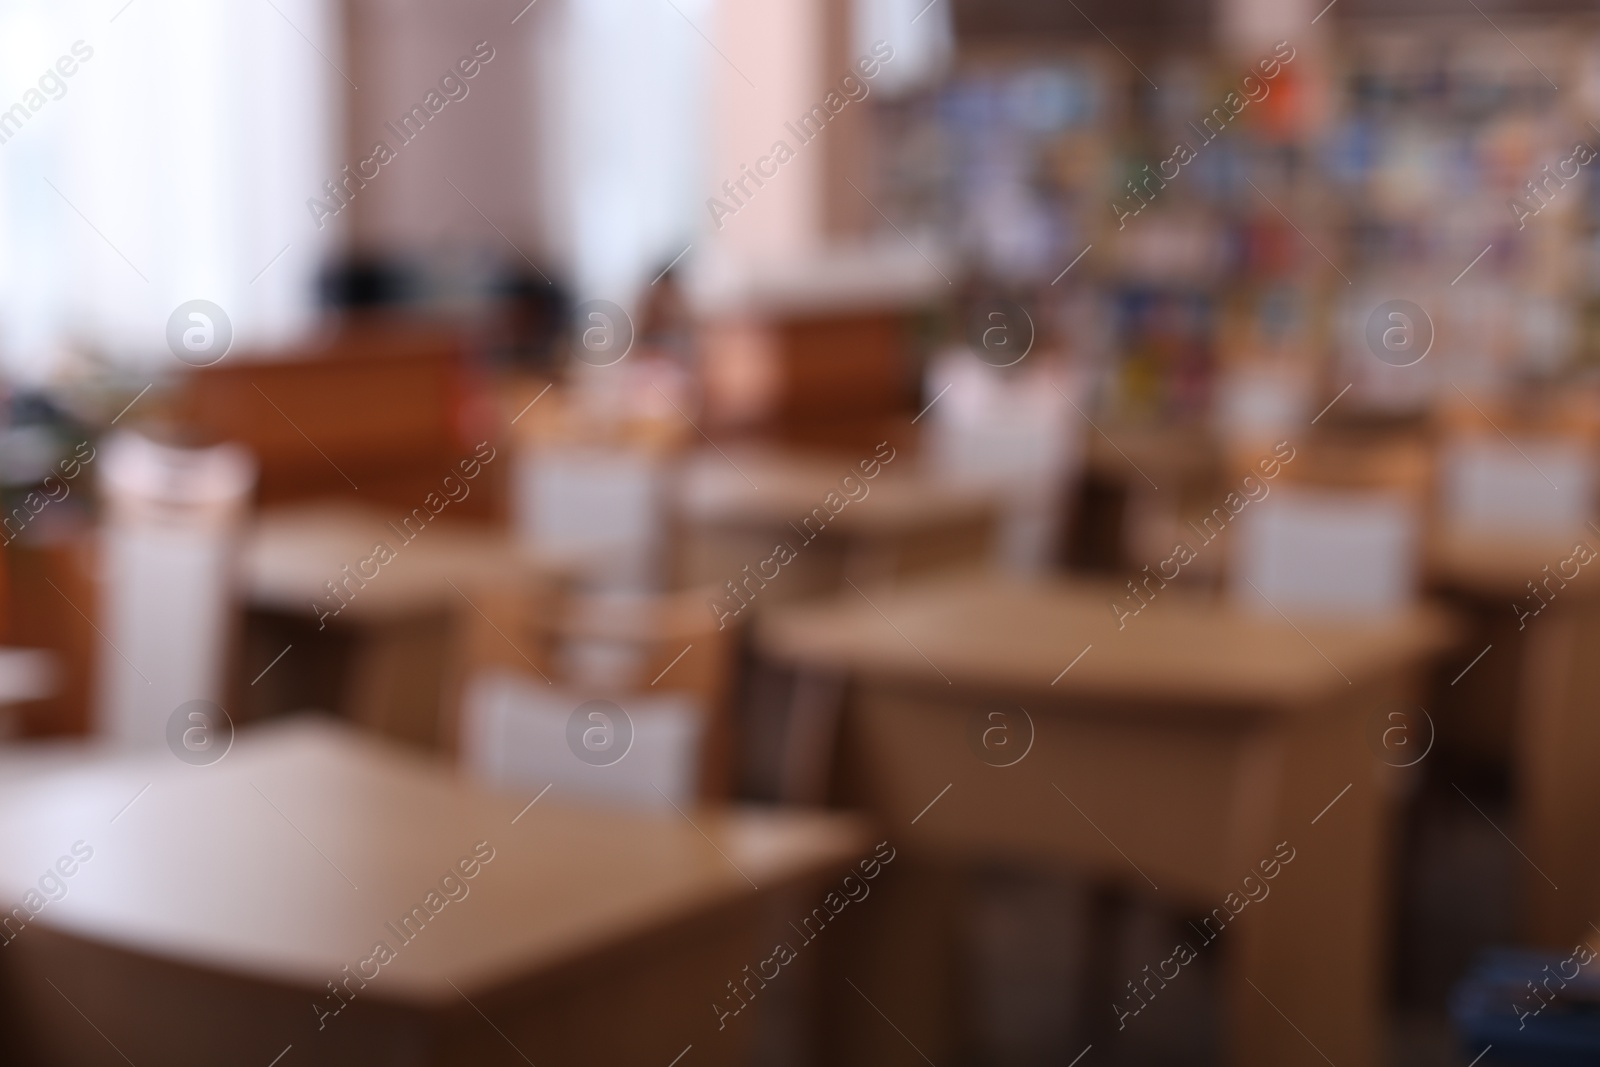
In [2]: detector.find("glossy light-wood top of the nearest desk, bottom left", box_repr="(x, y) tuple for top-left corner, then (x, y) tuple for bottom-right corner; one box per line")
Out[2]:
(0, 720), (870, 1005)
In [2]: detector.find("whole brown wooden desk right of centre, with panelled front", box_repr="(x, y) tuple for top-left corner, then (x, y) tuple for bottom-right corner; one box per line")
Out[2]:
(757, 574), (1451, 1067)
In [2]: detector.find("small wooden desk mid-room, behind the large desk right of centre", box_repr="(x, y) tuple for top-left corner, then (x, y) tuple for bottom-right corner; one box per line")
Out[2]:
(674, 448), (997, 608)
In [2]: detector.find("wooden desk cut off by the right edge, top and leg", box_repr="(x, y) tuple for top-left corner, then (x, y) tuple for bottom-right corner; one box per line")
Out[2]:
(1429, 530), (1600, 949)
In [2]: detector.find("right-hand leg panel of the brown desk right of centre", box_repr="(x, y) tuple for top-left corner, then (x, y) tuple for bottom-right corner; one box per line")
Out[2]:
(1216, 693), (1390, 1067)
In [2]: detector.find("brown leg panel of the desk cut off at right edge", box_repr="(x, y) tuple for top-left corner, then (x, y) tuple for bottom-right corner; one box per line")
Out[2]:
(1507, 603), (1600, 949)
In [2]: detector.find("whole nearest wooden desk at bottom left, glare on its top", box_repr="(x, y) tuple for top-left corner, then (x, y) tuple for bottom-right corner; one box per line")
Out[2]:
(0, 721), (870, 1067)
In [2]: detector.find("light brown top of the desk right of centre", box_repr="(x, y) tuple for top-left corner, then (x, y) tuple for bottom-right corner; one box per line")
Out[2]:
(757, 573), (1454, 707)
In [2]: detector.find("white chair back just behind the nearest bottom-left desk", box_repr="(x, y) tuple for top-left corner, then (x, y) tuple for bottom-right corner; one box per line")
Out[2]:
(461, 669), (704, 808)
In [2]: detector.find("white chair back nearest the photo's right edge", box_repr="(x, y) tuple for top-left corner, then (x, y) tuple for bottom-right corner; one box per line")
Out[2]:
(1440, 438), (1595, 537)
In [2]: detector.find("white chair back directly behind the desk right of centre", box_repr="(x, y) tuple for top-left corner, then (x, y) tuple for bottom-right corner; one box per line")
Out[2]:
(1232, 488), (1418, 616)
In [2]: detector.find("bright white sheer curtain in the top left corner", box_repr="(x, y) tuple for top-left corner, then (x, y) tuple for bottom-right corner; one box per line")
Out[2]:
(0, 0), (337, 381)
